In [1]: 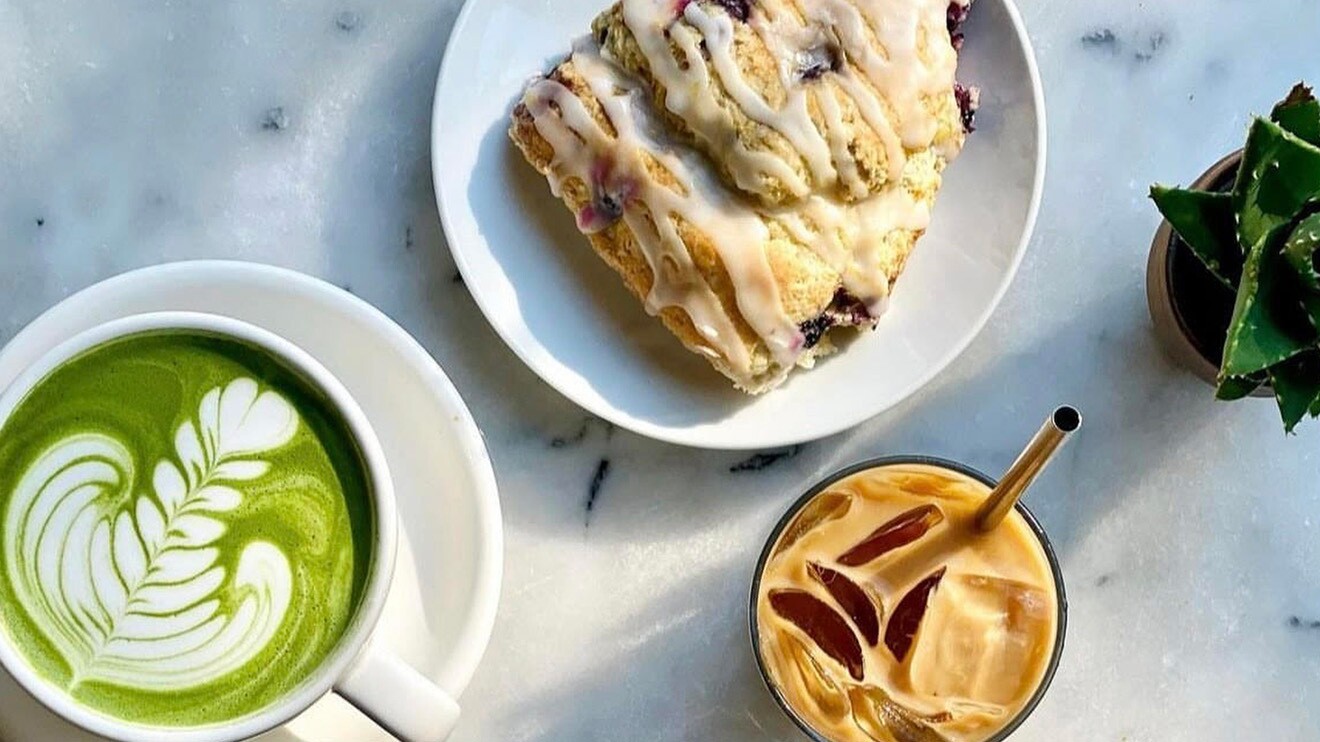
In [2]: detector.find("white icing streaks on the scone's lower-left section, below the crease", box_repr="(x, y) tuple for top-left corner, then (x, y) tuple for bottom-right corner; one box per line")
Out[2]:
(524, 49), (801, 382)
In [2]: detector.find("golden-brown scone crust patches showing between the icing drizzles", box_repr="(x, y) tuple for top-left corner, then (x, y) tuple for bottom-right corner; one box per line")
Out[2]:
(510, 0), (962, 393)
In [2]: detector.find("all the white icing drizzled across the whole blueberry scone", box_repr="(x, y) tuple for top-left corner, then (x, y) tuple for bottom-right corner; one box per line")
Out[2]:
(514, 0), (961, 387)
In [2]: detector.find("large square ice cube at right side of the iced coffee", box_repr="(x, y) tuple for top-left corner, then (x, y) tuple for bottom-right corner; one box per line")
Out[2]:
(908, 574), (1055, 706)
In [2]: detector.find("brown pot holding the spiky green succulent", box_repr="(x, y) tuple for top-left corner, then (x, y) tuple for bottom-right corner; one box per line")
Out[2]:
(1146, 149), (1274, 396)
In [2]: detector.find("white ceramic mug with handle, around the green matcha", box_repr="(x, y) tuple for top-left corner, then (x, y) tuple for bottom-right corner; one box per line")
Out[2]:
(0, 312), (458, 742)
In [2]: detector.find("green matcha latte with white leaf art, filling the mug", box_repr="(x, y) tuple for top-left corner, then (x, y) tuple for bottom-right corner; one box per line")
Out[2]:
(0, 330), (375, 726)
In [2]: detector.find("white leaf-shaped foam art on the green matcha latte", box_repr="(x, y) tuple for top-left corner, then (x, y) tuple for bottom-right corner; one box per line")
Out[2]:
(4, 378), (298, 691)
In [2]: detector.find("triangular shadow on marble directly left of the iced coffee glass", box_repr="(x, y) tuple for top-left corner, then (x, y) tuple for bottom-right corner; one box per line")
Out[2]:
(475, 561), (804, 742)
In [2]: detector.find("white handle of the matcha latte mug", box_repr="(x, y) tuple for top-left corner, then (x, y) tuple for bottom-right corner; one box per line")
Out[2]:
(334, 646), (458, 742)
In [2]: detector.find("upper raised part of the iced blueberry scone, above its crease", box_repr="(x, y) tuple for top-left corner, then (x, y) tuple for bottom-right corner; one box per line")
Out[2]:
(591, 0), (964, 206)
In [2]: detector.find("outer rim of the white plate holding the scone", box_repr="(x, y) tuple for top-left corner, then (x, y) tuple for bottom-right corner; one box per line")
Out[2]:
(430, 0), (1048, 450)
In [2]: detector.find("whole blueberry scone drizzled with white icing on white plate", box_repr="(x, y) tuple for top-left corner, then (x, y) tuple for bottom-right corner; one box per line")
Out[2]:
(510, 0), (975, 393)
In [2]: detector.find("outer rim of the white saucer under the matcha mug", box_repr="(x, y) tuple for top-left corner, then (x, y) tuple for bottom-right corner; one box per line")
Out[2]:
(0, 259), (504, 698)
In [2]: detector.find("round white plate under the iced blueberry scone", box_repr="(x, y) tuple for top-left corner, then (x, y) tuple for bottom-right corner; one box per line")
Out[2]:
(432, 0), (1045, 449)
